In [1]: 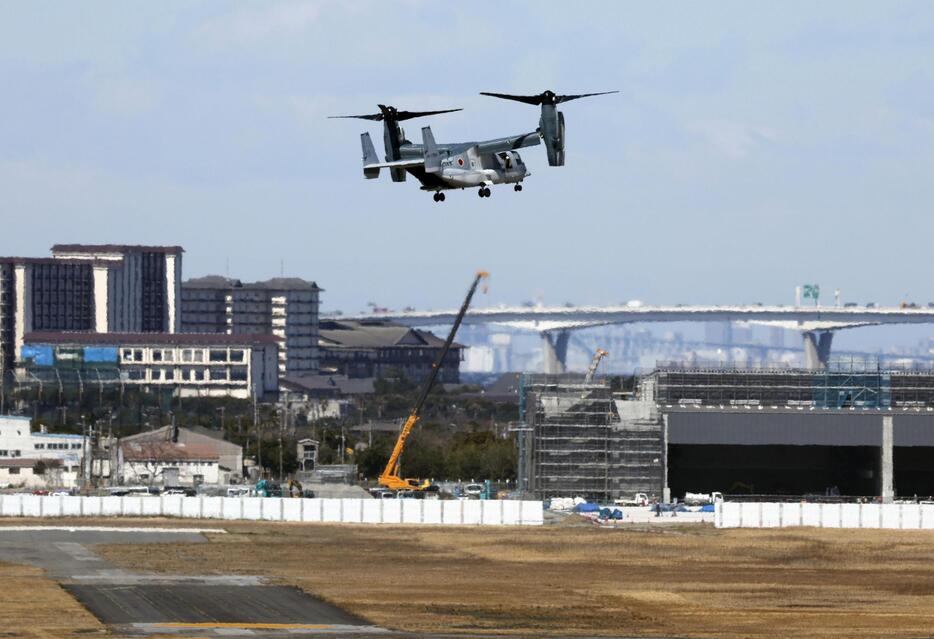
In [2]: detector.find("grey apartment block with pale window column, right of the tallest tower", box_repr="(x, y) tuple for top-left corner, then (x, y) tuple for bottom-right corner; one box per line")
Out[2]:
(181, 275), (322, 377)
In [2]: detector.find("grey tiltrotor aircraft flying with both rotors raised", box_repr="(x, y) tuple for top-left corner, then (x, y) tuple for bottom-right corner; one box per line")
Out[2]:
(332, 91), (618, 202)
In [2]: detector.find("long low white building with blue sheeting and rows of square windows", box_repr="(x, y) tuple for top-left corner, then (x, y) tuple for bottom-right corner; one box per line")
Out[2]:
(20, 331), (279, 399)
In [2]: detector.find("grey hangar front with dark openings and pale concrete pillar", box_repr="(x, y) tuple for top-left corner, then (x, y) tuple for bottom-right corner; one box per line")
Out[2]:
(660, 407), (934, 499)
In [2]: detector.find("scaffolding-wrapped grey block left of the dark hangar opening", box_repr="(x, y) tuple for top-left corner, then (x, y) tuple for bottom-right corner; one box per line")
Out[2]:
(519, 375), (663, 502)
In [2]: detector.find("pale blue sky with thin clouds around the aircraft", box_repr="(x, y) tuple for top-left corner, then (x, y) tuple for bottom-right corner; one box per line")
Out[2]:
(0, 1), (934, 318)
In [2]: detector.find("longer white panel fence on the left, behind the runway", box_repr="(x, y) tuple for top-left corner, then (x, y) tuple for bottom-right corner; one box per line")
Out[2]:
(0, 495), (543, 526)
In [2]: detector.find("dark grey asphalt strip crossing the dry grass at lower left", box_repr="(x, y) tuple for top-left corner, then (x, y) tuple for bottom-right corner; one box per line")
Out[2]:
(0, 527), (386, 637)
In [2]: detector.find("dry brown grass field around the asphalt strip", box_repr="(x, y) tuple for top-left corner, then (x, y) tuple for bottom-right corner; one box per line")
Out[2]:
(0, 516), (934, 637)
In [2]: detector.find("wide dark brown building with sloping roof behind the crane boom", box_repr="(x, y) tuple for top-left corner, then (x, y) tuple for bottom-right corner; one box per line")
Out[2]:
(319, 319), (464, 384)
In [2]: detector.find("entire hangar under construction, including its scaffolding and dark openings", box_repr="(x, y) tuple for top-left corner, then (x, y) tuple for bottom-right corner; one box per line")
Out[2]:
(519, 366), (934, 501)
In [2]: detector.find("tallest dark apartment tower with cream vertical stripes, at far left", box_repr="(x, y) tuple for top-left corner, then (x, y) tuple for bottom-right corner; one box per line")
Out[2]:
(0, 244), (182, 376)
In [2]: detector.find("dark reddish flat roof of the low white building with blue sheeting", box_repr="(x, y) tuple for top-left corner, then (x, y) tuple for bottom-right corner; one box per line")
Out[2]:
(23, 331), (281, 346)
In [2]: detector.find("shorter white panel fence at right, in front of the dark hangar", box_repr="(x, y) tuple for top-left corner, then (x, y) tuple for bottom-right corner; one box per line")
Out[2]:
(714, 501), (934, 530)
